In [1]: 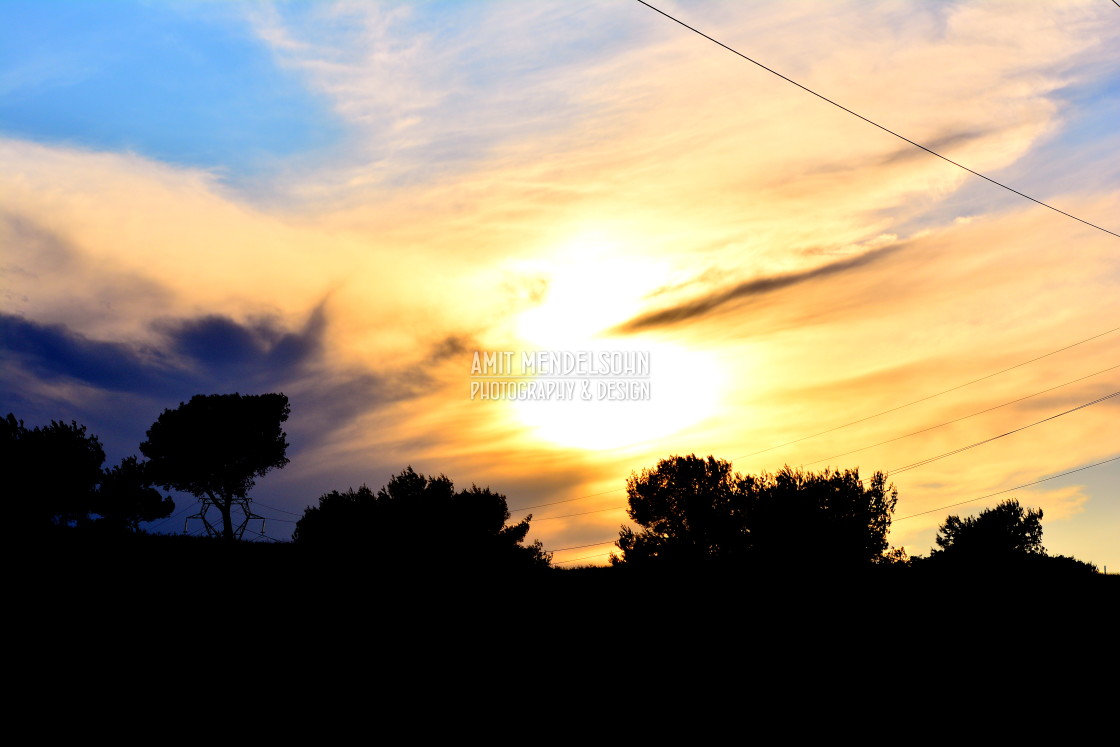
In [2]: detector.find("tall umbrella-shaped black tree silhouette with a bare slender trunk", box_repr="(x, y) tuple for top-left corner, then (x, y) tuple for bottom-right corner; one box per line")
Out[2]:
(140, 394), (289, 540)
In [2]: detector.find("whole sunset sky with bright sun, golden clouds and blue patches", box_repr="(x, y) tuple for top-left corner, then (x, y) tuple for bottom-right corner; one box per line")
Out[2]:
(0, 0), (1120, 570)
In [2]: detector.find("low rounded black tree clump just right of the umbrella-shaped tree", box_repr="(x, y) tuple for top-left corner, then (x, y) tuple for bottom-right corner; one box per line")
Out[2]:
(292, 467), (551, 569)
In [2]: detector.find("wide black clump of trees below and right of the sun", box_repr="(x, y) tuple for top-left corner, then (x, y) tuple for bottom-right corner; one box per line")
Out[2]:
(612, 455), (898, 566)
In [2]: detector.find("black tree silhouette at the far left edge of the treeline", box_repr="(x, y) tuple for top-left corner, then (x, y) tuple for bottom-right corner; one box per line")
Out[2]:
(0, 413), (105, 531)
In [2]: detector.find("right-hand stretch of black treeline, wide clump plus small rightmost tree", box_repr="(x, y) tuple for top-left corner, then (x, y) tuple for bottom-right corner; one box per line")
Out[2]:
(610, 455), (1098, 575)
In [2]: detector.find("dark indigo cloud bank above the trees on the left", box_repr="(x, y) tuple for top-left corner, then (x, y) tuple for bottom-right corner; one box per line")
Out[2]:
(0, 305), (421, 450)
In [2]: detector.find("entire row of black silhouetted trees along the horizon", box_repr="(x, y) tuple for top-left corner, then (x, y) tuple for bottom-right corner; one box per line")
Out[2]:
(0, 394), (1096, 576)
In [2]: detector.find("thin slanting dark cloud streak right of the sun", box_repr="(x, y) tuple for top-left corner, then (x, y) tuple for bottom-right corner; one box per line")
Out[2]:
(614, 244), (903, 335)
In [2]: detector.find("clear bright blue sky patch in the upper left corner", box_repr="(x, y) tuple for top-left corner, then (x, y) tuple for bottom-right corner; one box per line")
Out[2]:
(0, 2), (343, 172)
